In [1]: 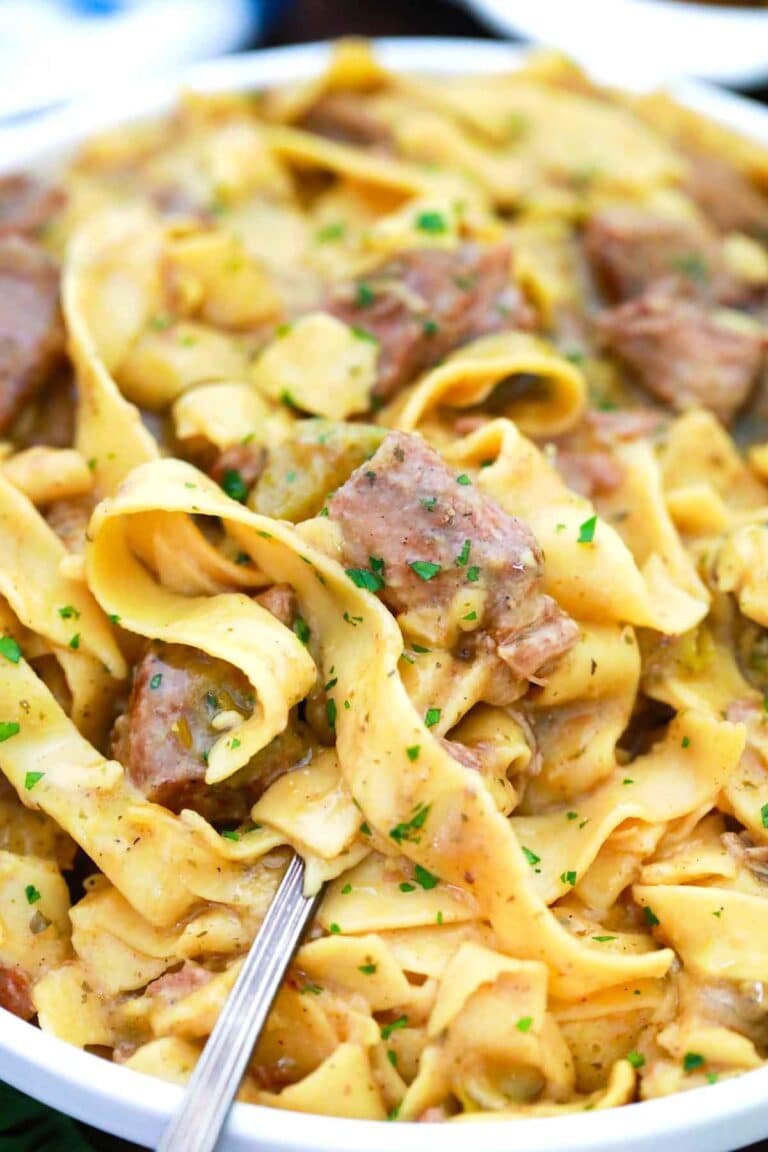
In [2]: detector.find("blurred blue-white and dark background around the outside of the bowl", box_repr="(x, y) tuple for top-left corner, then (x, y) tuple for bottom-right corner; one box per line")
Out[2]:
(0, 0), (768, 1152)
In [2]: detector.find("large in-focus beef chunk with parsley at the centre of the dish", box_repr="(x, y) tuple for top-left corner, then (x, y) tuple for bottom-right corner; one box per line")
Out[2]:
(329, 432), (577, 677)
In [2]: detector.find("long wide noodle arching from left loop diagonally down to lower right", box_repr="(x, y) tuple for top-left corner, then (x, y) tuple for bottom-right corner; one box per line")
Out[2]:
(88, 461), (671, 995)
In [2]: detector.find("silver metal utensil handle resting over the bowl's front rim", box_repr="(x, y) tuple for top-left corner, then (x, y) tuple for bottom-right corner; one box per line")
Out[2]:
(157, 856), (322, 1152)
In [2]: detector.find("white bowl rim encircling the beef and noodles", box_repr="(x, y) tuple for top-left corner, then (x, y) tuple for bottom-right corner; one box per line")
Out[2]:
(0, 39), (768, 1152)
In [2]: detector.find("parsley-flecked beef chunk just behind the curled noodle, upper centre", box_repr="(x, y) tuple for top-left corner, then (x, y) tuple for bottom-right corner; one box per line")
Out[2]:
(329, 244), (534, 400)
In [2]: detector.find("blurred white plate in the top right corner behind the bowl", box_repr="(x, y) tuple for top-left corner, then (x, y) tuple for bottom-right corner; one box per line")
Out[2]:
(458, 0), (768, 88)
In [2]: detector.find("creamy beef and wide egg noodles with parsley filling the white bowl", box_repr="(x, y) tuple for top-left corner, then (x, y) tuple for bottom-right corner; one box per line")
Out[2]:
(0, 41), (768, 1122)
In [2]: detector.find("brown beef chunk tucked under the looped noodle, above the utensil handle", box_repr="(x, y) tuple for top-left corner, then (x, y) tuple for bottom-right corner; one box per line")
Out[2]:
(112, 643), (306, 821)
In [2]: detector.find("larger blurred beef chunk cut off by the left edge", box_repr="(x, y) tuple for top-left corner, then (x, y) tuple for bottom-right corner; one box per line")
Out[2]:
(0, 236), (64, 433)
